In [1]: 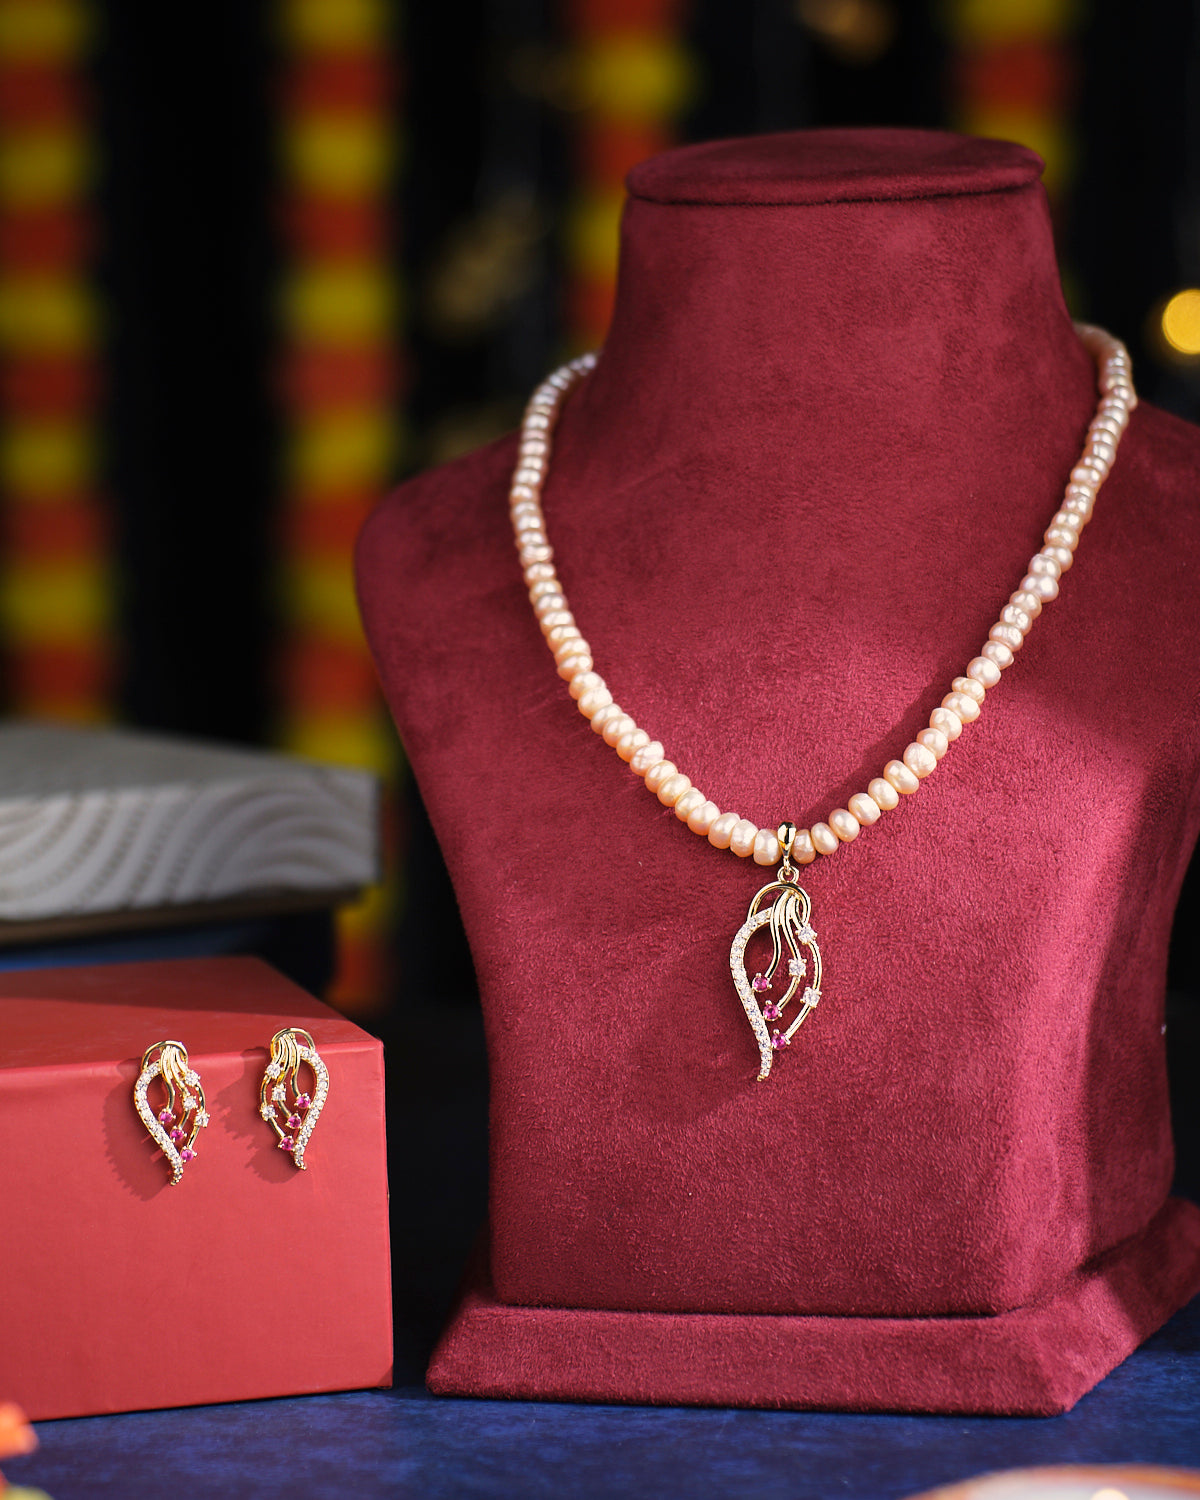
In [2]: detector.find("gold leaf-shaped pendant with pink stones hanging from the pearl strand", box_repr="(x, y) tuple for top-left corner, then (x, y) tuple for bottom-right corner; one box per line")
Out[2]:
(729, 824), (821, 1083)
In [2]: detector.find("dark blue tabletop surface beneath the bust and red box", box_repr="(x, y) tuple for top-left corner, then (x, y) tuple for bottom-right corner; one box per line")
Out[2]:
(6, 1301), (1200, 1500)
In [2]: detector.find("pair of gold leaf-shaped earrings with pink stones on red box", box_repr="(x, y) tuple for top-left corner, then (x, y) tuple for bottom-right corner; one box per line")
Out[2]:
(134, 1026), (329, 1187)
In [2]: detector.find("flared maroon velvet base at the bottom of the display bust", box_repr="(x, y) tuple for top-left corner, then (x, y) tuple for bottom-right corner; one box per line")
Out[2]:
(426, 1199), (1200, 1416)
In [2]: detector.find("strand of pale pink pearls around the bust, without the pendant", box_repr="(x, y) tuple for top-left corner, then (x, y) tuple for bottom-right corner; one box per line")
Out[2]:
(509, 324), (1137, 866)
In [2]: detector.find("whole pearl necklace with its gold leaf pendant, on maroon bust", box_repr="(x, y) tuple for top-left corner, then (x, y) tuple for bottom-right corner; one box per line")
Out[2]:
(509, 324), (1137, 1080)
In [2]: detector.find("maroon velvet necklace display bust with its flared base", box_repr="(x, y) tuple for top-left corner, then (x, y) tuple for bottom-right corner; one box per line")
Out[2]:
(359, 131), (1200, 1412)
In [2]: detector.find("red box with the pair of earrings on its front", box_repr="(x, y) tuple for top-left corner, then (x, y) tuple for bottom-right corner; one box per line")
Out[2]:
(0, 959), (392, 1421)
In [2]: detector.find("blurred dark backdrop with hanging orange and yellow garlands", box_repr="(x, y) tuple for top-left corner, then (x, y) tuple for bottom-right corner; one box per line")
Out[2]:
(0, 0), (1200, 1362)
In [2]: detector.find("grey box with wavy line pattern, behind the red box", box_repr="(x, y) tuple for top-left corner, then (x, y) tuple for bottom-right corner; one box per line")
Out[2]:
(0, 723), (380, 927)
